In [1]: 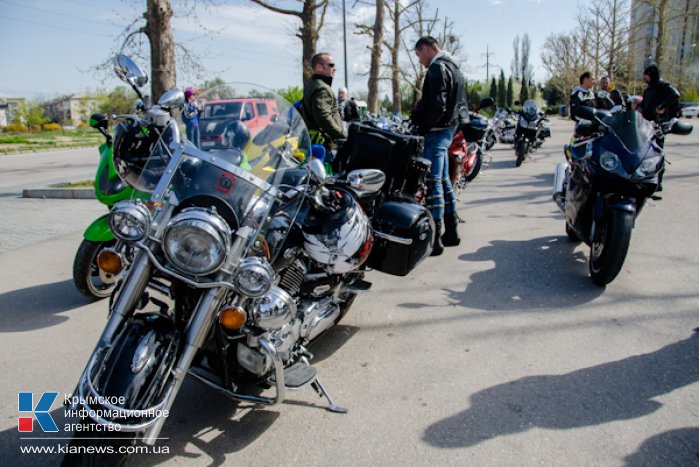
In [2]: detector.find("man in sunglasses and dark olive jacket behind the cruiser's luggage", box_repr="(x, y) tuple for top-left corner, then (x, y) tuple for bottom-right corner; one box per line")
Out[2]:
(302, 53), (346, 150)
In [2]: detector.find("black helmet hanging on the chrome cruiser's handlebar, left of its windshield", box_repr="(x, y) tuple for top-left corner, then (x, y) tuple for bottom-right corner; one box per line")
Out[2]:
(112, 122), (168, 192)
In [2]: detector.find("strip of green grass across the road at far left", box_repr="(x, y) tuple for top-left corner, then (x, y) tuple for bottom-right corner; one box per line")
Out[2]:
(0, 128), (104, 154)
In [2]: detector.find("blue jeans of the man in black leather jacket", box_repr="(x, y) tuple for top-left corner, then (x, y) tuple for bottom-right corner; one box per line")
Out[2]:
(423, 128), (457, 220)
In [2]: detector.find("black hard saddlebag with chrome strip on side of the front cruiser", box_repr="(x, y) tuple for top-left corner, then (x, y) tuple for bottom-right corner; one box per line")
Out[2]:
(369, 201), (435, 276)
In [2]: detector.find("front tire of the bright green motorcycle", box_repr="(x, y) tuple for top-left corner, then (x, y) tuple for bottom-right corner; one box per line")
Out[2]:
(73, 240), (117, 300)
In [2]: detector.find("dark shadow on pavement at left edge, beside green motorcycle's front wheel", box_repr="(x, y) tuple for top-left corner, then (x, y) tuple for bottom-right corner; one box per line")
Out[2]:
(0, 280), (91, 332)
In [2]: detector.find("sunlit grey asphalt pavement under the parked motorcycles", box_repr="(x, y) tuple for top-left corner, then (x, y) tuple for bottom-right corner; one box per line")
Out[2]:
(0, 119), (699, 466)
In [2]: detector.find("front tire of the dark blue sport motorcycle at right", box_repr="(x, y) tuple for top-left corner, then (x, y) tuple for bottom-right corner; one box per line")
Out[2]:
(588, 209), (634, 286)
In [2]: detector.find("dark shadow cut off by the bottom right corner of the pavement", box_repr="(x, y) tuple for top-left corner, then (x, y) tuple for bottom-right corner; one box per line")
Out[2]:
(625, 427), (698, 467)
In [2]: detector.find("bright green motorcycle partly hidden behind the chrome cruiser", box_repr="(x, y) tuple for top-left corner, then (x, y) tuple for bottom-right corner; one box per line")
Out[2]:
(73, 112), (145, 300)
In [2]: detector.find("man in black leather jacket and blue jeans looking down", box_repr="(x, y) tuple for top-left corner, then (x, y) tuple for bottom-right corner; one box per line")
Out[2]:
(411, 36), (467, 256)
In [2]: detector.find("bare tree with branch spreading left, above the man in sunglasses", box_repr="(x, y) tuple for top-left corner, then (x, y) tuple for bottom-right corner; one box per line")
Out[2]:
(250, 0), (329, 83)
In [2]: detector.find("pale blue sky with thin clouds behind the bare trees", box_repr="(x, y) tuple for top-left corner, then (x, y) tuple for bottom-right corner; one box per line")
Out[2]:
(0, 0), (577, 99)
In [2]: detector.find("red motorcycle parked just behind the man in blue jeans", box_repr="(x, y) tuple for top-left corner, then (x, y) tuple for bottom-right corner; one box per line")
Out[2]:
(447, 97), (493, 193)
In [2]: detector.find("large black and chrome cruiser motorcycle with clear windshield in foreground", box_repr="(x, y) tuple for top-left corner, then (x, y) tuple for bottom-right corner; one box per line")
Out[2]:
(64, 55), (432, 465)
